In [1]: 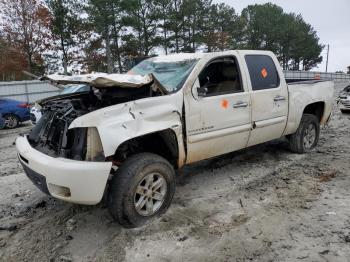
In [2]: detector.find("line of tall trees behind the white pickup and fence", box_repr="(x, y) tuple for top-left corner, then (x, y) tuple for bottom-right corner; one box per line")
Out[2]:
(0, 0), (324, 80)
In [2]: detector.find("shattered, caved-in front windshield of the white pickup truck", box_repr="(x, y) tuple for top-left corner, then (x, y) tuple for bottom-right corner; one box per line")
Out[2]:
(128, 57), (198, 92)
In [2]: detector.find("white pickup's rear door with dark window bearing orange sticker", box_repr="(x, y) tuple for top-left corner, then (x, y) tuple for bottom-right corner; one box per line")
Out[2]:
(241, 51), (288, 146)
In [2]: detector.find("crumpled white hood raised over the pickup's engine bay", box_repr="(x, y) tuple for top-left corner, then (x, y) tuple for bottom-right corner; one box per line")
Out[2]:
(41, 73), (154, 88)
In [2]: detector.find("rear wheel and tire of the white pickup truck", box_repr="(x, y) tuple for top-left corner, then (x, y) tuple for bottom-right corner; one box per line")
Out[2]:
(288, 114), (320, 154)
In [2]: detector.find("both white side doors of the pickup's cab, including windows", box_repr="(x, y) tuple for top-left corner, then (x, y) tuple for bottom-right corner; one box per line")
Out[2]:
(185, 51), (288, 162)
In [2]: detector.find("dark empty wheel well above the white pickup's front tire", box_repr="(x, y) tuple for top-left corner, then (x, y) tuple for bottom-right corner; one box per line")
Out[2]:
(113, 129), (179, 168)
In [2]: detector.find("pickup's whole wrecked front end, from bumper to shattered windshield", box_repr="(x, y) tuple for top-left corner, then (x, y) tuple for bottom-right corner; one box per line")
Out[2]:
(16, 56), (196, 205)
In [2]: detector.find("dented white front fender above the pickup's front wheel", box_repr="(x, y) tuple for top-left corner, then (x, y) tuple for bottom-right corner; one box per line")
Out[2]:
(69, 91), (185, 164)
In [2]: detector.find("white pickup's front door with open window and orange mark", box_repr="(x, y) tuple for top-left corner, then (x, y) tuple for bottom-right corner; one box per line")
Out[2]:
(185, 56), (252, 163)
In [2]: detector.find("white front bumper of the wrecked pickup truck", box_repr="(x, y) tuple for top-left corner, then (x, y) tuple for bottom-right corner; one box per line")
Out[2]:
(16, 136), (112, 205)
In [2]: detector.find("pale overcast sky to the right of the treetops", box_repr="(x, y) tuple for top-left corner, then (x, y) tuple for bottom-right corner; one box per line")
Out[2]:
(214, 0), (350, 72)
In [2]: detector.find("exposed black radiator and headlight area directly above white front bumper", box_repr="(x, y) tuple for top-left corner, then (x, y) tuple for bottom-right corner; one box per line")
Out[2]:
(28, 99), (105, 161)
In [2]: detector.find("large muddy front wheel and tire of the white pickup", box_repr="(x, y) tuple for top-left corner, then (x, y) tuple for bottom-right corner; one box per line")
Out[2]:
(107, 153), (176, 228)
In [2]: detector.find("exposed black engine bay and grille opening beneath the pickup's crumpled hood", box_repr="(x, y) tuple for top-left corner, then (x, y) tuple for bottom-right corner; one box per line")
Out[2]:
(28, 78), (167, 161)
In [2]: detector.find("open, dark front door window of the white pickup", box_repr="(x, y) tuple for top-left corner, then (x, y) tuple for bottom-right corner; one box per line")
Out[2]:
(199, 57), (243, 96)
